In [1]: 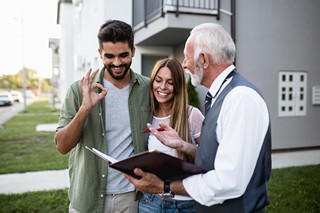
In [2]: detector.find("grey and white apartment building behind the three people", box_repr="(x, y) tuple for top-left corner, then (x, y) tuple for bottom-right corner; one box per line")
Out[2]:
(58, 0), (320, 150)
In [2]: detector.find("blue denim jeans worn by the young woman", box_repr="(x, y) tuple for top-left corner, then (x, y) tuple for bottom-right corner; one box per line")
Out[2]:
(138, 193), (196, 213)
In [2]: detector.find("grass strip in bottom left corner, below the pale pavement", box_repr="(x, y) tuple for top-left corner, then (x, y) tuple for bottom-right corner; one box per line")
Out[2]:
(0, 189), (69, 213)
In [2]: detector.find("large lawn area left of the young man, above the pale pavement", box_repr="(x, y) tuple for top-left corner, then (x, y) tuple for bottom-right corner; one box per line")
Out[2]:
(0, 99), (68, 174)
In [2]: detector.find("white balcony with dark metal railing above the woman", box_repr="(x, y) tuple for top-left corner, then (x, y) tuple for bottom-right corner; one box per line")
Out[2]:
(132, 0), (220, 46)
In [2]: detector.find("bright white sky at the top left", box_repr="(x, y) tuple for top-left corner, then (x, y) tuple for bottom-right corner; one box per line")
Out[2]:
(0, 0), (60, 78)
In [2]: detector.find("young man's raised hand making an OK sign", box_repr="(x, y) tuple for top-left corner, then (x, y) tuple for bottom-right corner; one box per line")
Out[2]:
(80, 69), (108, 112)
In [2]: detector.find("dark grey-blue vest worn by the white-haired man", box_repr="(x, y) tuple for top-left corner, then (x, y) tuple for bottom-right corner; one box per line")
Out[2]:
(195, 73), (271, 213)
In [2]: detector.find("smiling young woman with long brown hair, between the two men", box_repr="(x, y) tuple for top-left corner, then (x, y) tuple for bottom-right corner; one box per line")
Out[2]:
(139, 58), (204, 213)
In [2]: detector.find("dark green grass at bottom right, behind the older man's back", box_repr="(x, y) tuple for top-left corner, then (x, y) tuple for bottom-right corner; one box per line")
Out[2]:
(268, 165), (320, 213)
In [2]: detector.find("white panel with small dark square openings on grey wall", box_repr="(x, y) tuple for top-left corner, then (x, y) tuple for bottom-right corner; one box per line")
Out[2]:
(278, 71), (307, 116)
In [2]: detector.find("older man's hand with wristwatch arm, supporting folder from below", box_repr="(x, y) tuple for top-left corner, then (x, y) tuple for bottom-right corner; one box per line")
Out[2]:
(123, 168), (164, 194)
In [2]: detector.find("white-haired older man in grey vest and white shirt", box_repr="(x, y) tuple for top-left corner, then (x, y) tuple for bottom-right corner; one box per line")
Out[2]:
(126, 23), (271, 212)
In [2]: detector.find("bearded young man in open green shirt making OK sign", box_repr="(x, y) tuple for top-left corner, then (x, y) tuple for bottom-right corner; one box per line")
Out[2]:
(55, 20), (151, 213)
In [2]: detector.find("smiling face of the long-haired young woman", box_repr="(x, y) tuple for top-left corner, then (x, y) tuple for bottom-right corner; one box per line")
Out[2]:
(152, 67), (174, 104)
